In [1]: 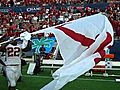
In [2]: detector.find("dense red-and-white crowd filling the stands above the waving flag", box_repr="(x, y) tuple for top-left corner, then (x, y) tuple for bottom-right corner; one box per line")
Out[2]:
(0, 0), (120, 37)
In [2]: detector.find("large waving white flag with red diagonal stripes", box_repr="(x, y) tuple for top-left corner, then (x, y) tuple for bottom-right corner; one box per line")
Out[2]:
(32, 14), (113, 90)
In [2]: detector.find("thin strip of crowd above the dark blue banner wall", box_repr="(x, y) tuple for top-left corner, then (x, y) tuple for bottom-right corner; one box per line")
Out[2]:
(0, 0), (109, 7)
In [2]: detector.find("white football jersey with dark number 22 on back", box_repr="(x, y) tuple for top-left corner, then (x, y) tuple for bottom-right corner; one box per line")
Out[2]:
(5, 44), (22, 65)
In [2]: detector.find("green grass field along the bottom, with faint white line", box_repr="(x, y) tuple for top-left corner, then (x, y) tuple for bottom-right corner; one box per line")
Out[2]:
(0, 65), (120, 90)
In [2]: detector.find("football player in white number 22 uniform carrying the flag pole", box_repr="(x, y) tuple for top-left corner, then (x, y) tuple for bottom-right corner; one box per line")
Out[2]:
(1, 32), (31, 90)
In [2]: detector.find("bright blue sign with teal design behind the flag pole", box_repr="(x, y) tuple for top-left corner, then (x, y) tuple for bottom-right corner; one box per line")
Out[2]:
(32, 37), (55, 54)
